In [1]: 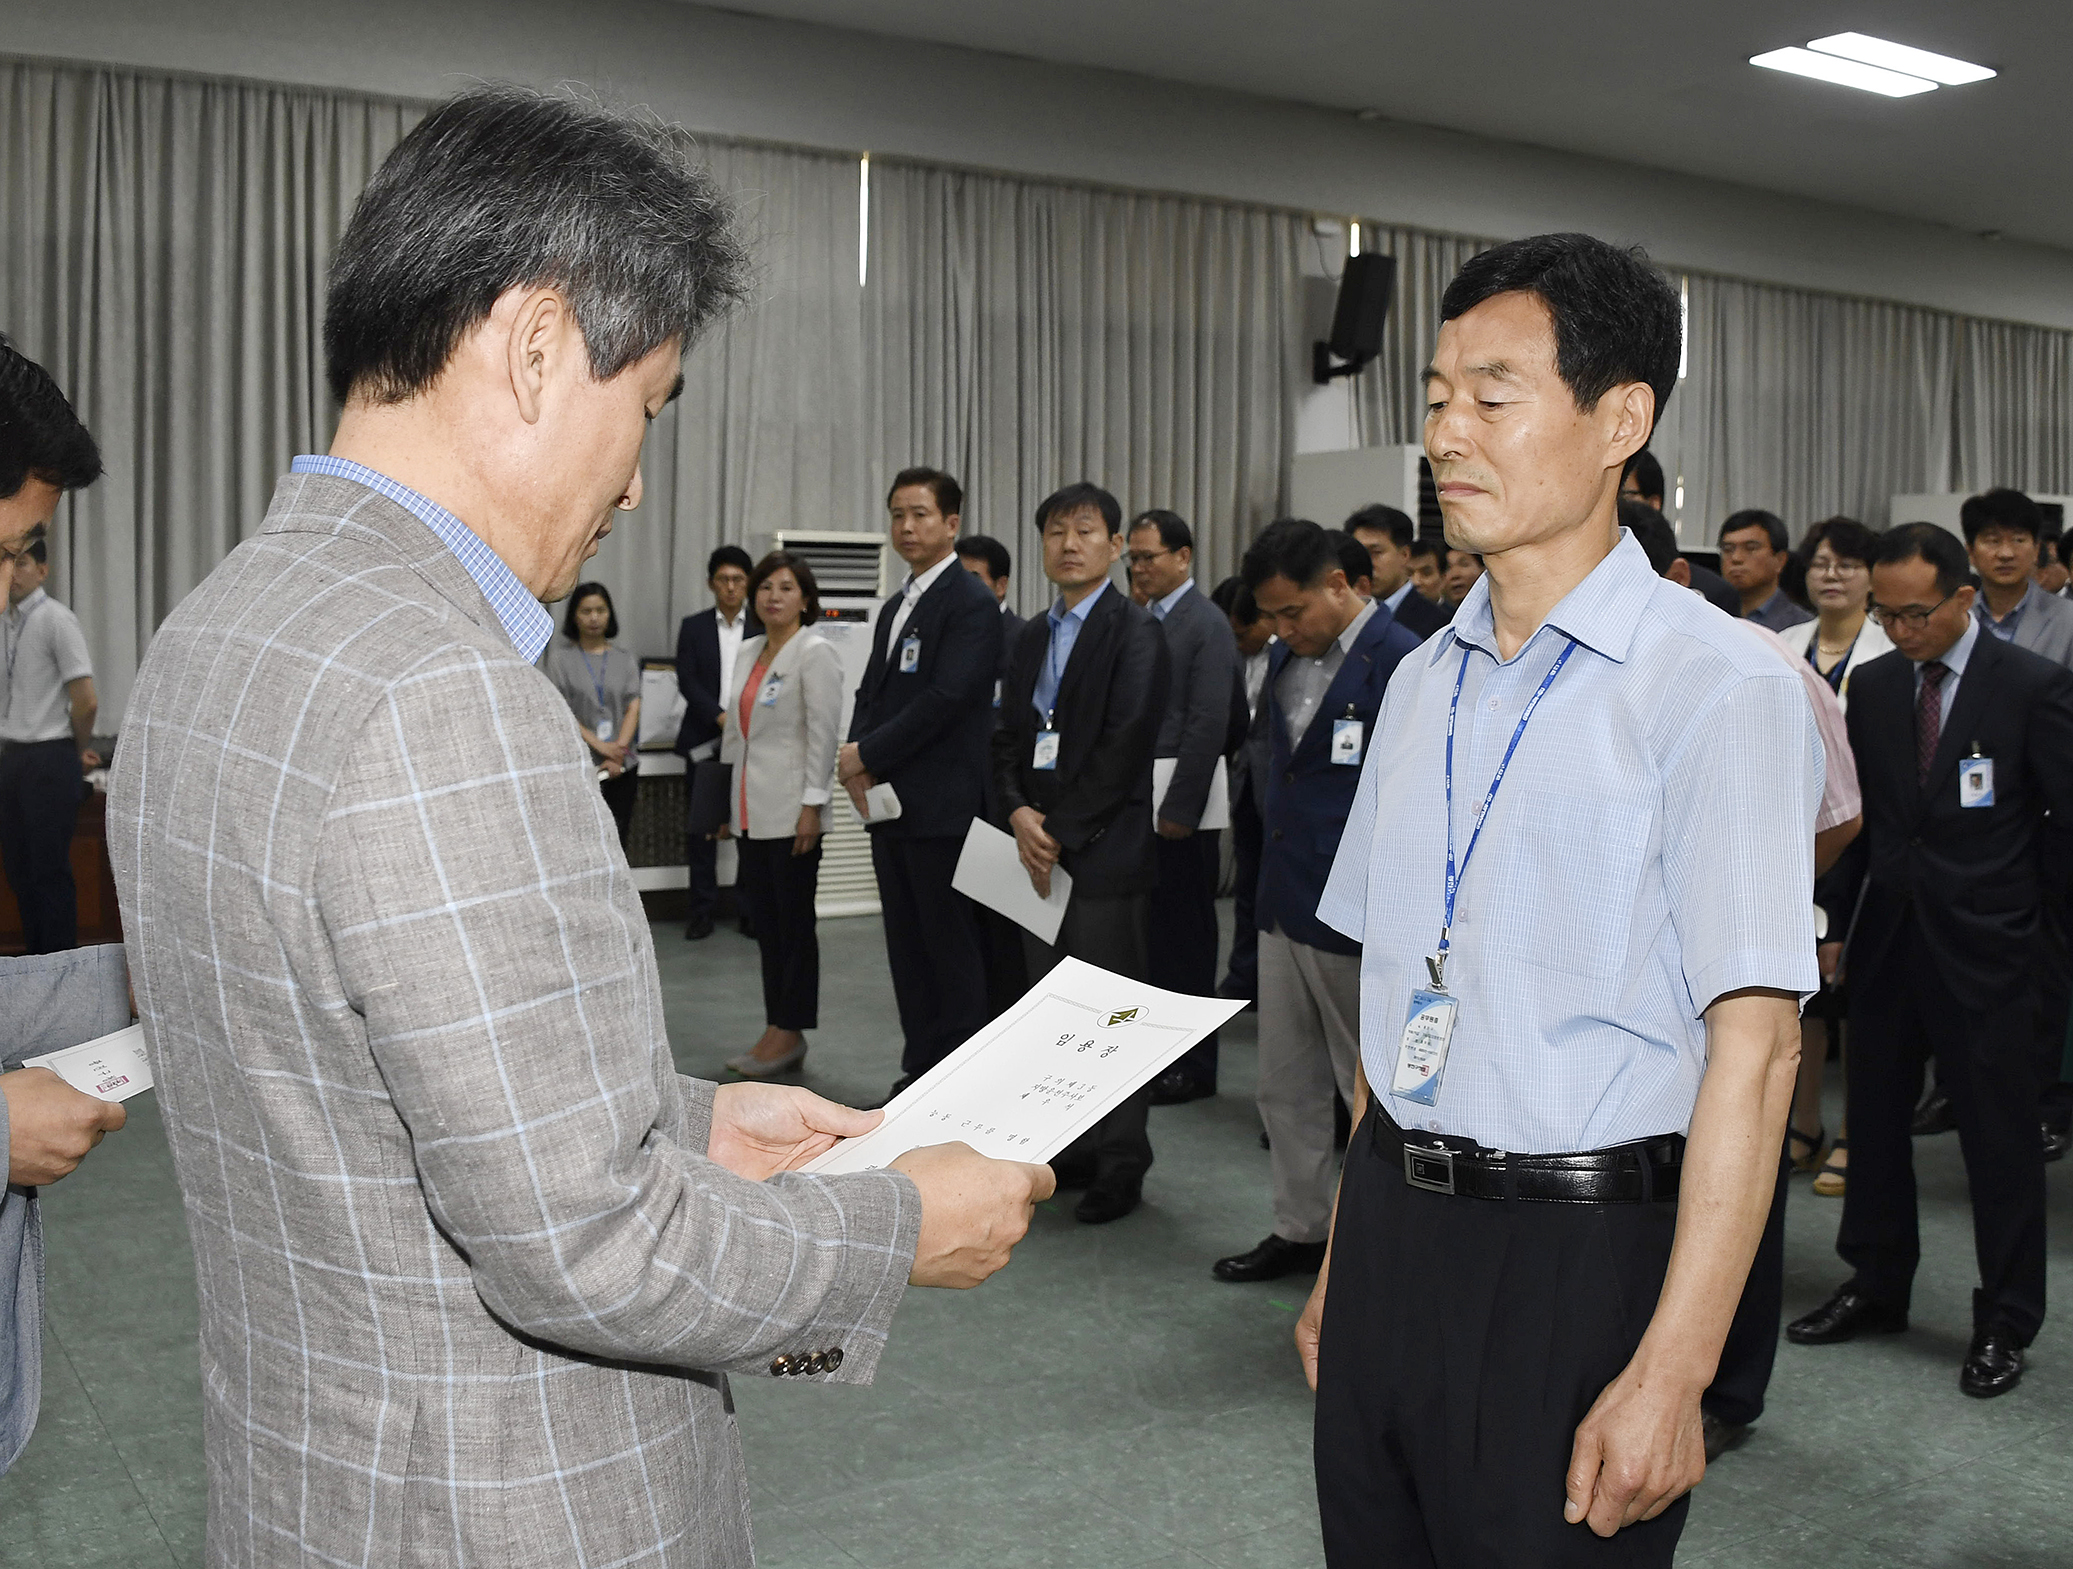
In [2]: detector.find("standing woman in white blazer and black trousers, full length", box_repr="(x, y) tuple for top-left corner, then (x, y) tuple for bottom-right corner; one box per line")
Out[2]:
(719, 551), (842, 1078)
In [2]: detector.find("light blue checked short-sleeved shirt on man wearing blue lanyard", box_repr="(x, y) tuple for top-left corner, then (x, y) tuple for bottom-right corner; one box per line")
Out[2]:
(1318, 535), (1822, 1154)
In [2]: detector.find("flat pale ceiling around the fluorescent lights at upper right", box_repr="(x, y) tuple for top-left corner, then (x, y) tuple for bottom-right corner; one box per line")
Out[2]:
(700, 0), (2073, 247)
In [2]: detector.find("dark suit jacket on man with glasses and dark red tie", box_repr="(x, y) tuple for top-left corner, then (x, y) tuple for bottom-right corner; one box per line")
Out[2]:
(1849, 632), (2073, 1009)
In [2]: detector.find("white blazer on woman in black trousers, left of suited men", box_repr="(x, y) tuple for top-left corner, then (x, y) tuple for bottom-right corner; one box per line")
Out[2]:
(719, 626), (842, 839)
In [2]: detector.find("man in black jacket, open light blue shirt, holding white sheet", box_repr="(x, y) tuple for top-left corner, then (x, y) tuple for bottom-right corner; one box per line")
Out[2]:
(993, 481), (1169, 1225)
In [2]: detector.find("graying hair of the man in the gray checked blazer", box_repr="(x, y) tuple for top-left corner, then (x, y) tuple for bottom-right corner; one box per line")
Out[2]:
(323, 85), (748, 402)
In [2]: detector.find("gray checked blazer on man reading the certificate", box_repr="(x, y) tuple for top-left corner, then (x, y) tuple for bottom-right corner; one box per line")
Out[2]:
(108, 475), (920, 1569)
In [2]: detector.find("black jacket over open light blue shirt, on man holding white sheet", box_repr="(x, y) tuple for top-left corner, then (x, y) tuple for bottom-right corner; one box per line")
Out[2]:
(993, 582), (1171, 900)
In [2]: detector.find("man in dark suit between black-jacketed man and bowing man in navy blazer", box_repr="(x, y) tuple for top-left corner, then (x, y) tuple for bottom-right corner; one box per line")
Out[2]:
(1128, 512), (1238, 1107)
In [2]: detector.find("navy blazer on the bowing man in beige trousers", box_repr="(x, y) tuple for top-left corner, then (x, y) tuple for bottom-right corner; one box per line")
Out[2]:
(1252, 601), (1418, 953)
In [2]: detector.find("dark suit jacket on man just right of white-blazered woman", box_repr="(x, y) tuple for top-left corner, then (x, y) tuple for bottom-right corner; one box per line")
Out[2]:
(850, 564), (1001, 839)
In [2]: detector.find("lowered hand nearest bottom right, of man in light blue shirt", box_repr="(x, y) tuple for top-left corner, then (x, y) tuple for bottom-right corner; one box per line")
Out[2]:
(1563, 1362), (1706, 1536)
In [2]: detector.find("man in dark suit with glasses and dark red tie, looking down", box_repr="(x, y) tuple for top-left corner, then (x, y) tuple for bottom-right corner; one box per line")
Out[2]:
(1787, 522), (2073, 1397)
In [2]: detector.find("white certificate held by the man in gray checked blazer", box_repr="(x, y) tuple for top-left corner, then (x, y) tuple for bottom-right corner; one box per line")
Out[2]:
(804, 960), (1244, 1173)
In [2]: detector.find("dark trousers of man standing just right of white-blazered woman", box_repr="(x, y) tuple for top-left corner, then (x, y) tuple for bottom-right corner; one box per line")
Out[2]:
(871, 833), (991, 1078)
